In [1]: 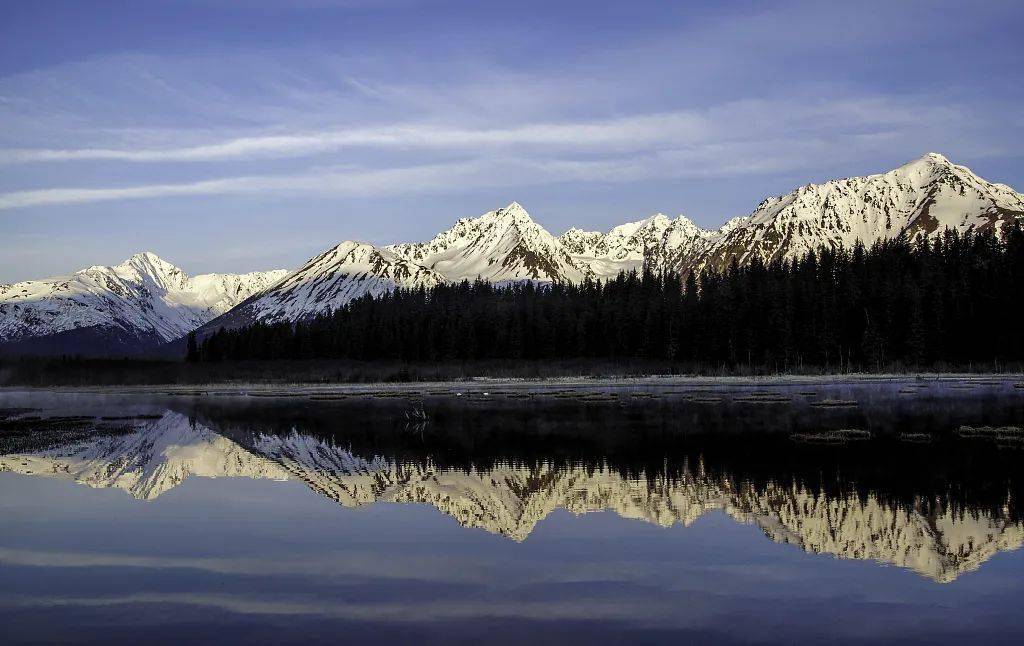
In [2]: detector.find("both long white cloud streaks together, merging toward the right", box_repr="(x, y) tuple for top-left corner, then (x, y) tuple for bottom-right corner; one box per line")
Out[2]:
(0, 97), (991, 210)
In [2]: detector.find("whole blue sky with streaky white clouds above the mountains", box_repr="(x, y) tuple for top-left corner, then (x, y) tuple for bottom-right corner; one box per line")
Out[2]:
(0, 0), (1024, 283)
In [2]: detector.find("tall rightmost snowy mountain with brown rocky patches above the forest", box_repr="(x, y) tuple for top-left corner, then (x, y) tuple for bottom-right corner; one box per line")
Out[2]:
(688, 153), (1024, 271)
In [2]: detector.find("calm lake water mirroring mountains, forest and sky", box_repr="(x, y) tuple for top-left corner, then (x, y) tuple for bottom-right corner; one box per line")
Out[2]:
(0, 381), (1024, 644)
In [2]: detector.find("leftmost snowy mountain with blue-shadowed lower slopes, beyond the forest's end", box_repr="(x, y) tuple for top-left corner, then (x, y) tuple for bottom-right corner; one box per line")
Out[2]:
(0, 252), (288, 354)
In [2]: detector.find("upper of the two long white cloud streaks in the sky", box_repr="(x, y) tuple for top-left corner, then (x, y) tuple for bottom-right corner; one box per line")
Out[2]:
(0, 98), (963, 164)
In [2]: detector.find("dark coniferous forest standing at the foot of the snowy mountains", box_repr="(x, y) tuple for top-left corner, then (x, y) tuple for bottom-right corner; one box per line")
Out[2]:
(197, 223), (1024, 372)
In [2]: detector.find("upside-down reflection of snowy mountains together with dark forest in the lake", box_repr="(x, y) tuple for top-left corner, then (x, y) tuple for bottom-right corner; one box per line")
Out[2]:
(0, 380), (1024, 583)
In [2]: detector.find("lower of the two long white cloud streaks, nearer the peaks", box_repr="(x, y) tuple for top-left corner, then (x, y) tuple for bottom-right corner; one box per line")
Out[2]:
(0, 115), (1007, 210)
